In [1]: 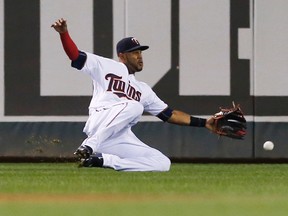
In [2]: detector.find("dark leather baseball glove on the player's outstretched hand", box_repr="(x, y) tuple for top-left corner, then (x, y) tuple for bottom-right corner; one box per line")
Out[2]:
(213, 102), (247, 139)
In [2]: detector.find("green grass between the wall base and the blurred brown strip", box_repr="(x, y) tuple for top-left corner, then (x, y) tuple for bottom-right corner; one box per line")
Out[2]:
(0, 163), (288, 196)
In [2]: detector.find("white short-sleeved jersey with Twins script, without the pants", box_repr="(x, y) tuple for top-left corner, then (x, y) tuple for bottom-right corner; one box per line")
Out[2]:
(81, 52), (167, 116)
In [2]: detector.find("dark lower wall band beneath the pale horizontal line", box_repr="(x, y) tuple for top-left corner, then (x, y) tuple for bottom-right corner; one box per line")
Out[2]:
(0, 122), (288, 161)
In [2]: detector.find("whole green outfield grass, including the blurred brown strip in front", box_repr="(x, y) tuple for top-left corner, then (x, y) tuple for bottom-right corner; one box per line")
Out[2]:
(0, 163), (288, 216)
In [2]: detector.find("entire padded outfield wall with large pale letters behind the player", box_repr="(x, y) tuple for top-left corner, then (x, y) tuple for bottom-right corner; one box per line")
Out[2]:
(0, 0), (288, 160)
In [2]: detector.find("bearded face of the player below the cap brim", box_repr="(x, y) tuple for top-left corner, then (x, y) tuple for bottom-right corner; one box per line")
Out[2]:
(122, 50), (143, 74)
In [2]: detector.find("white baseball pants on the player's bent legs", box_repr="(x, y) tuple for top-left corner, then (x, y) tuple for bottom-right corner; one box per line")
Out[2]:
(82, 101), (171, 171)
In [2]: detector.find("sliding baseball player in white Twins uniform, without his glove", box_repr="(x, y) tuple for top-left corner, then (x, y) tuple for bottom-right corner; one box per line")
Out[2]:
(51, 19), (218, 171)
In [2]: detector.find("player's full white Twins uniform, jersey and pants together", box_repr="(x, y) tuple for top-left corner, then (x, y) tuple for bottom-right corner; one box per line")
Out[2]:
(74, 52), (171, 171)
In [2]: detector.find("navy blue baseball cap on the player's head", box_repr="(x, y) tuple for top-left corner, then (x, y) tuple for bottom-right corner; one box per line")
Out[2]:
(116, 37), (149, 55)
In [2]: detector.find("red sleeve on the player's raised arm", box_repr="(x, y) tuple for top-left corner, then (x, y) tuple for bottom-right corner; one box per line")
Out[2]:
(60, 31), (79, 61)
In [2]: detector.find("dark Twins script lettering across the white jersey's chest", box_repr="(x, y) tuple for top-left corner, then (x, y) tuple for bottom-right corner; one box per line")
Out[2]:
(105, 73), (141, 101)
